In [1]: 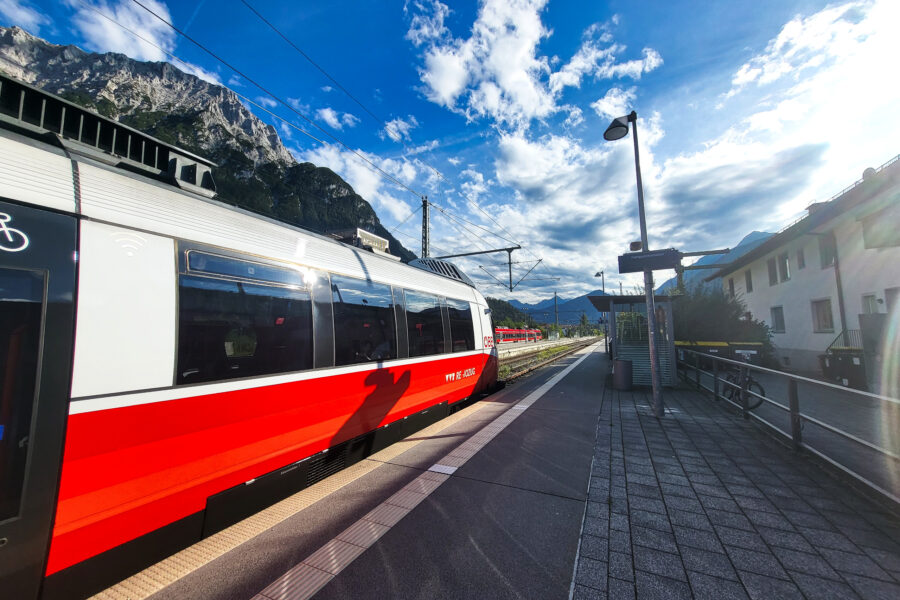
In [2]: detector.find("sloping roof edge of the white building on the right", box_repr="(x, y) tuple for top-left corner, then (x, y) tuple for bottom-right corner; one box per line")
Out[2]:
(704, 155), (900, 281)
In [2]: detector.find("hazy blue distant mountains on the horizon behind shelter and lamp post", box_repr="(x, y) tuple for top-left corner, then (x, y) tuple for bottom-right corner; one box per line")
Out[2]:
(509, 231), (773, 325)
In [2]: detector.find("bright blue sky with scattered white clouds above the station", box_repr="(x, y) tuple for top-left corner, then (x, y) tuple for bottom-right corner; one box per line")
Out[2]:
(0, 0), (900, 302)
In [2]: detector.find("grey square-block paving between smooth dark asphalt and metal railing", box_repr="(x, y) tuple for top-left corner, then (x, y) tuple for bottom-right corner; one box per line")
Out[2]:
(574, 382), (900, 599)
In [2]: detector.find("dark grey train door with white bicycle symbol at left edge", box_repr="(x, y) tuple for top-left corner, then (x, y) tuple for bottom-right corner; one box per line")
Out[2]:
(0, 199), (77, 599)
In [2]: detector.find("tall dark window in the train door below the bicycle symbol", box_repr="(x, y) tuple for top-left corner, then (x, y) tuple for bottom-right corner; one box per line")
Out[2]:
(0, 269), (44, 521)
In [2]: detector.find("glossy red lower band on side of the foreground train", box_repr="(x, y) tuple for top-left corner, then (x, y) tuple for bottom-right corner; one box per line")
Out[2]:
(47, 354), (488, 575)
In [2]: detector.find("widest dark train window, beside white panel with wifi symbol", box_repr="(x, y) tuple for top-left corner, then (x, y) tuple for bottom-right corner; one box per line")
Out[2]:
(176, 275), (313, 384)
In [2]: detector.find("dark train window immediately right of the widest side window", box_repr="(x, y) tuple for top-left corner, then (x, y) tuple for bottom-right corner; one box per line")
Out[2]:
(331, 275), (397, 365)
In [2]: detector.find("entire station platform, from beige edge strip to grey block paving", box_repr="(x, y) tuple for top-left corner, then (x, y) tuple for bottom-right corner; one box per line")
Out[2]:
(97, 344), (900, 600)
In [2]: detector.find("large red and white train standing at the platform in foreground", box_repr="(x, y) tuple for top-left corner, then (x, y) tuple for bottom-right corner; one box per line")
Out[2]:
(0, 78), (497, 599)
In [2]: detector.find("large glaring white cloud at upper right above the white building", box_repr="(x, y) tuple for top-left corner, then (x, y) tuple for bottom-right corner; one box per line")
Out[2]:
(708, 0), (900, 214)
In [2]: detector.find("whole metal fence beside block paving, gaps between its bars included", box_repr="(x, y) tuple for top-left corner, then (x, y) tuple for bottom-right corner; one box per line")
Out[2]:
(677, 348), (900, 507)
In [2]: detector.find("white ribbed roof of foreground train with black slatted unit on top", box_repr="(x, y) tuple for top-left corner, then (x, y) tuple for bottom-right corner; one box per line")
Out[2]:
(0, 76), (484, 303)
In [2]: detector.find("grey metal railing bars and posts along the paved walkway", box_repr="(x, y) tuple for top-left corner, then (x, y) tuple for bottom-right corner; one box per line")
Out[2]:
(676, 348), (900, 507)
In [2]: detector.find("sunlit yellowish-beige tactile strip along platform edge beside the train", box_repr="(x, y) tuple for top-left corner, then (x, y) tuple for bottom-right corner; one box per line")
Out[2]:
(92, 402), (497, 600)
